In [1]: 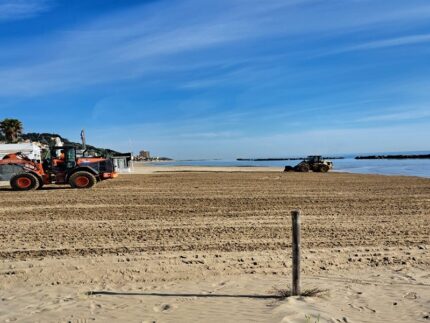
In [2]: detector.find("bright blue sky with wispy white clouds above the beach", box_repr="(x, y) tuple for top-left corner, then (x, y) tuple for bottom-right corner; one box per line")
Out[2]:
(0, 0), (430, 158)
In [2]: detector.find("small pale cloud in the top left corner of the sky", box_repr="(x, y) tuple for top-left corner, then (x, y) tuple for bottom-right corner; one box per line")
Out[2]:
(0, 0), (52, 22)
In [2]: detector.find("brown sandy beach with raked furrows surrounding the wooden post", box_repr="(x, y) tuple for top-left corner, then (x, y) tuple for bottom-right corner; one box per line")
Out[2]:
(0, 170), (430, 323)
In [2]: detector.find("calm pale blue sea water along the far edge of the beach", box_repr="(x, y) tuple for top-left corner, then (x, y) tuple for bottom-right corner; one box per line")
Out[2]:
(149, 158), (430, 178)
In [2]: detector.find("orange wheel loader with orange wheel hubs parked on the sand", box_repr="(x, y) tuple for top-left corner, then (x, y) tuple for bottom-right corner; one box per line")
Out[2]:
(0, 146), (117, 191)
